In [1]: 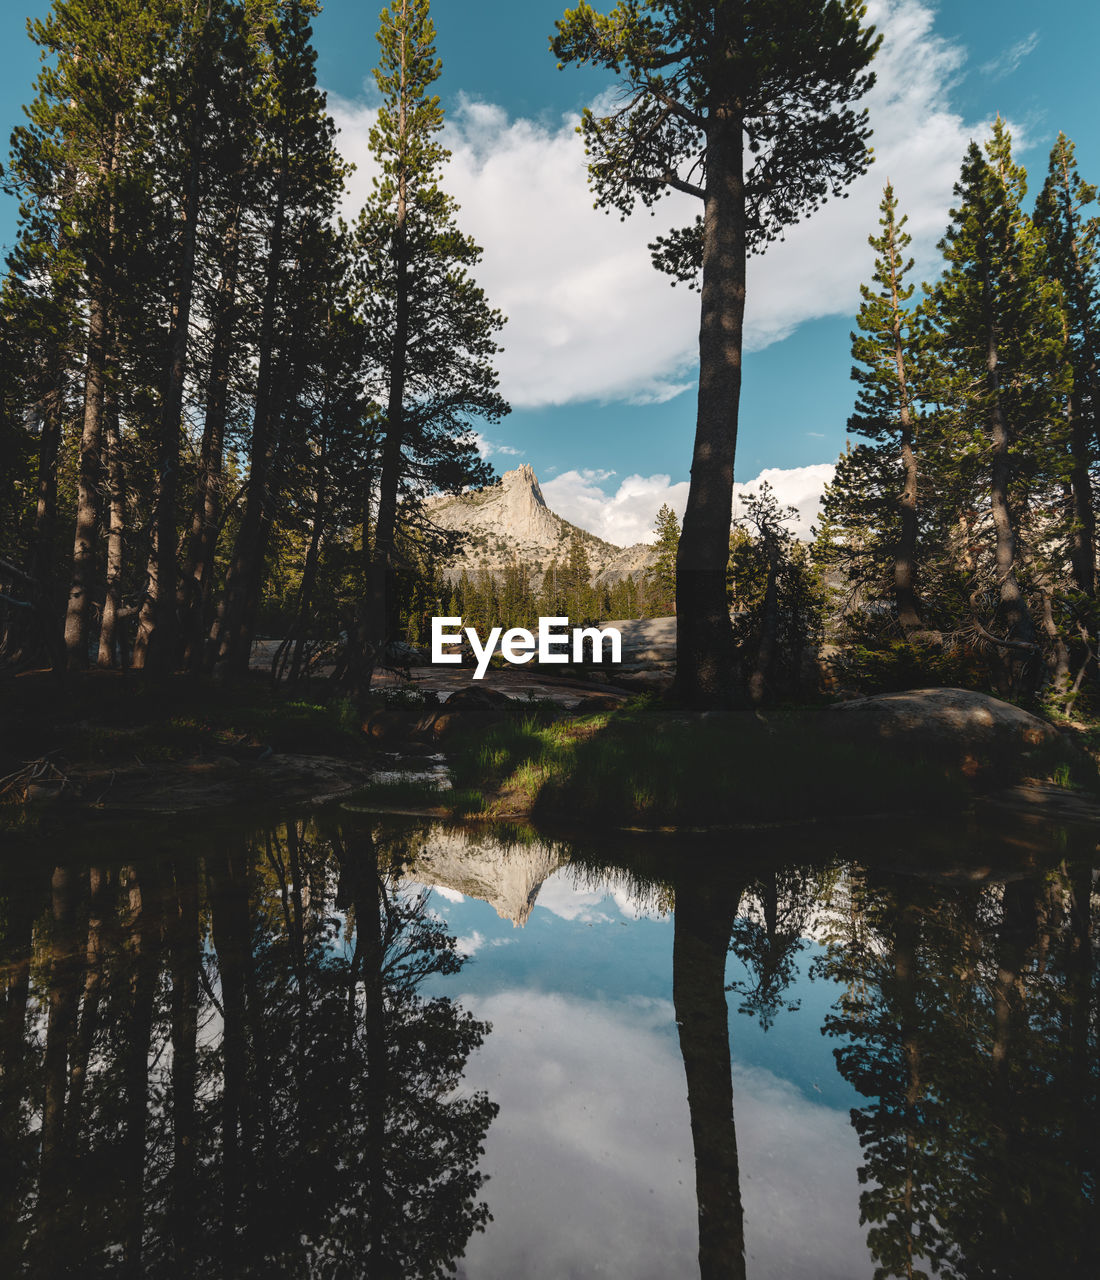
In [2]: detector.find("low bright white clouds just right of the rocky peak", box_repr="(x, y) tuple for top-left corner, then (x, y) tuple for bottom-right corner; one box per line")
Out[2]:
(542, 462), (834, 547)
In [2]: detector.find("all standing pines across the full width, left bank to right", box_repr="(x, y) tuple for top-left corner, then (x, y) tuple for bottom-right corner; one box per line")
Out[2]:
(0, 0), (1100, 713)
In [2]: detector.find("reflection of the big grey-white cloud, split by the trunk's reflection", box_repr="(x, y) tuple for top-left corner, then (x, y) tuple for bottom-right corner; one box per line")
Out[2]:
(461, 991), (871, 1280)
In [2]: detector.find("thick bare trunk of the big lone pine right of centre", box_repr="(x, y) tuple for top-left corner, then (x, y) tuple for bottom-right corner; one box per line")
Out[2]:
(676, 109), (745, 708)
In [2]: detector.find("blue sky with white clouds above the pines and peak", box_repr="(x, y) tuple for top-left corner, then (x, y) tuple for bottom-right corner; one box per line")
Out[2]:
(0, 0), (1100, 544)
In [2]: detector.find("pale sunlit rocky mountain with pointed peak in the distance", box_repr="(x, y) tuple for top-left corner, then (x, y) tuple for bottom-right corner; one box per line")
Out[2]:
(426, 463), (654, 584)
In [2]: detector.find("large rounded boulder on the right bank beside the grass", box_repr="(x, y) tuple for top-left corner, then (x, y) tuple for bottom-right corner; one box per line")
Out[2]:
(822, 689), (1071, 782)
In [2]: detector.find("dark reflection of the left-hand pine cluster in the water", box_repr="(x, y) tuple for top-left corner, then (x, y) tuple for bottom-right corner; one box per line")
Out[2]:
(0, 824), (496, 1277)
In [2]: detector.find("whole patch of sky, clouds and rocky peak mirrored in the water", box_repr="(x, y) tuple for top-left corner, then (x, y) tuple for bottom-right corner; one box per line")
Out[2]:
(409, 855), (873, 1280)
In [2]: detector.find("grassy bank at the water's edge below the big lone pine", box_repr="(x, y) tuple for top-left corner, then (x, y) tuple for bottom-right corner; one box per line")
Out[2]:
(432, 701), (969, 827)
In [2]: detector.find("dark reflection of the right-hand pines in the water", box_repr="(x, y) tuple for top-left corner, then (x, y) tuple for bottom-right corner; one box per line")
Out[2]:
(822, 864), (1100, 1280)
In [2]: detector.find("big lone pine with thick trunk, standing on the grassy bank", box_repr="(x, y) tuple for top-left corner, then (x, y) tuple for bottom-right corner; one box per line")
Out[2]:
(551, 0), (878, 705)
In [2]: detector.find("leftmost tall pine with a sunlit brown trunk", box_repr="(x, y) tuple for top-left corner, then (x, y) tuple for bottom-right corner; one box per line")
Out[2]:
(12, 0), (164, 668)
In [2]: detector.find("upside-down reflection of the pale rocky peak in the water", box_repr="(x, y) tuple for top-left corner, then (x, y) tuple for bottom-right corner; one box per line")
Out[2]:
(408, 831), (569, 927)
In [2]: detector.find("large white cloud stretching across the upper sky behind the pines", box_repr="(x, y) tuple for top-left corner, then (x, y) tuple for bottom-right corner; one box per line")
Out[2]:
(329, 0), (1022, 409)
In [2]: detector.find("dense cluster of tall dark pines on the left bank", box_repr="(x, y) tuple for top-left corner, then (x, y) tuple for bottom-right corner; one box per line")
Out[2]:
(0, 0), (507, 684)
